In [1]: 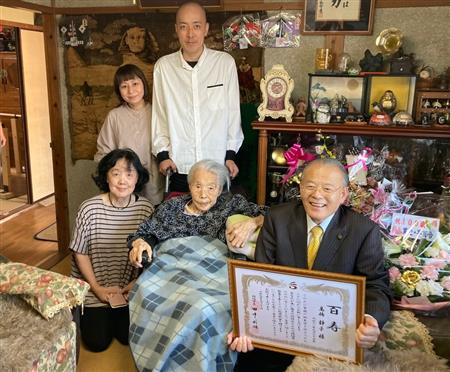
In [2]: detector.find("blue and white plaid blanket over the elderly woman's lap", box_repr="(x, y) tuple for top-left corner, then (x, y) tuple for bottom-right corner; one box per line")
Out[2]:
(130, 236), (237, 372)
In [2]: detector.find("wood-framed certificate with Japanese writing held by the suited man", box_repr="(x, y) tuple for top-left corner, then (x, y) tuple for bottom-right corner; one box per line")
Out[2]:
(228, 260), (365, 363)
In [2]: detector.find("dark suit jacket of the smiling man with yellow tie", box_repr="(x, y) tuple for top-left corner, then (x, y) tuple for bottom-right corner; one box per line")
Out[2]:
(255, 201), (391, 328)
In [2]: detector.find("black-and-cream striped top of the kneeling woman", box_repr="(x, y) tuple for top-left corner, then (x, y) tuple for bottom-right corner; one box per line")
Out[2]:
(69, 195), (154, 307)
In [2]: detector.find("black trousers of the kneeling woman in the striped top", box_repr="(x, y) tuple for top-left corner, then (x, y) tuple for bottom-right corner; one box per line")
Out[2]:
(74, 306), (130, 352)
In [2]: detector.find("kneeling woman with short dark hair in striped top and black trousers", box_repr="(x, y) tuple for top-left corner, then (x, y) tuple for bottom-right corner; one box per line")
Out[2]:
(70, 149), (154, 352)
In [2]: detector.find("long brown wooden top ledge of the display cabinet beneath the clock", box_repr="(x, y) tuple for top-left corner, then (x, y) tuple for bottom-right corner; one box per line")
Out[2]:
(252, 120), (450, 139)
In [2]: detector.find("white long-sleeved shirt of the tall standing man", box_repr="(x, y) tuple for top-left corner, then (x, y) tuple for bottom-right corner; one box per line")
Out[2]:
(152, 47), (244, 174)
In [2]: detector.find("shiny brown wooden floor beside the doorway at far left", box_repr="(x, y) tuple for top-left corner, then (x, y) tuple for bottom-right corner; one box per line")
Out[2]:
(0, 203), (67, 269)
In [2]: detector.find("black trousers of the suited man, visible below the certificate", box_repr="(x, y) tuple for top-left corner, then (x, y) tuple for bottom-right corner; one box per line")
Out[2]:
(234, 349), (294, 372)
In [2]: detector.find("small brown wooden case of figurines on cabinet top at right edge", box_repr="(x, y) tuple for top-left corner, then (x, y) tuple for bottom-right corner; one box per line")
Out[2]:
(414, 89), (450, 129)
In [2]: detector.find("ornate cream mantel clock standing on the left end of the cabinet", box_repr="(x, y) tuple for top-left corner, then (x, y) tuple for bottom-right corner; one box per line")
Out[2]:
(258, 64), (295, 123)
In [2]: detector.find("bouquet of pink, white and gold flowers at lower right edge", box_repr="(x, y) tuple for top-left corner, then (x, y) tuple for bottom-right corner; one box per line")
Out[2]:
(383, 225), (450, 311)
